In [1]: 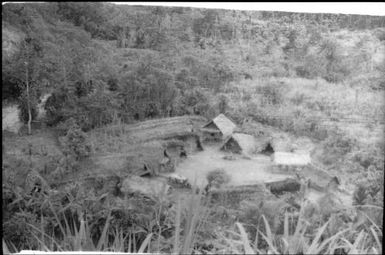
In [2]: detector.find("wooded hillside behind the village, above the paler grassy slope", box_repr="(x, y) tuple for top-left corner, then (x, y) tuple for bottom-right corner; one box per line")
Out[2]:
(2, 3), (385, 126)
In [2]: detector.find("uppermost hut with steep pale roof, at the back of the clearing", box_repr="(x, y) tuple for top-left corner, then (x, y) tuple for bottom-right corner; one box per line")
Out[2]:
(201, 114), (236, 141)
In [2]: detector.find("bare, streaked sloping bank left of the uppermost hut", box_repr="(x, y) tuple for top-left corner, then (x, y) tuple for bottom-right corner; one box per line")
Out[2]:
(79, 116), (207, 177)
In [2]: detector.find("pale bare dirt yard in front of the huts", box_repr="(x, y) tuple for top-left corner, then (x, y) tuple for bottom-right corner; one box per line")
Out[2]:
(176, 144), (291, 187)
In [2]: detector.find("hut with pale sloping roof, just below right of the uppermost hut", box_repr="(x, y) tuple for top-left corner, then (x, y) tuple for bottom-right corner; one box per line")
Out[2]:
(221, 133), (255, 154)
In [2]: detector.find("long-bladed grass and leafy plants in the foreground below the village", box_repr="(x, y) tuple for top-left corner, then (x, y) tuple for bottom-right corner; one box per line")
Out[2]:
(1, 184), (383, 254)
